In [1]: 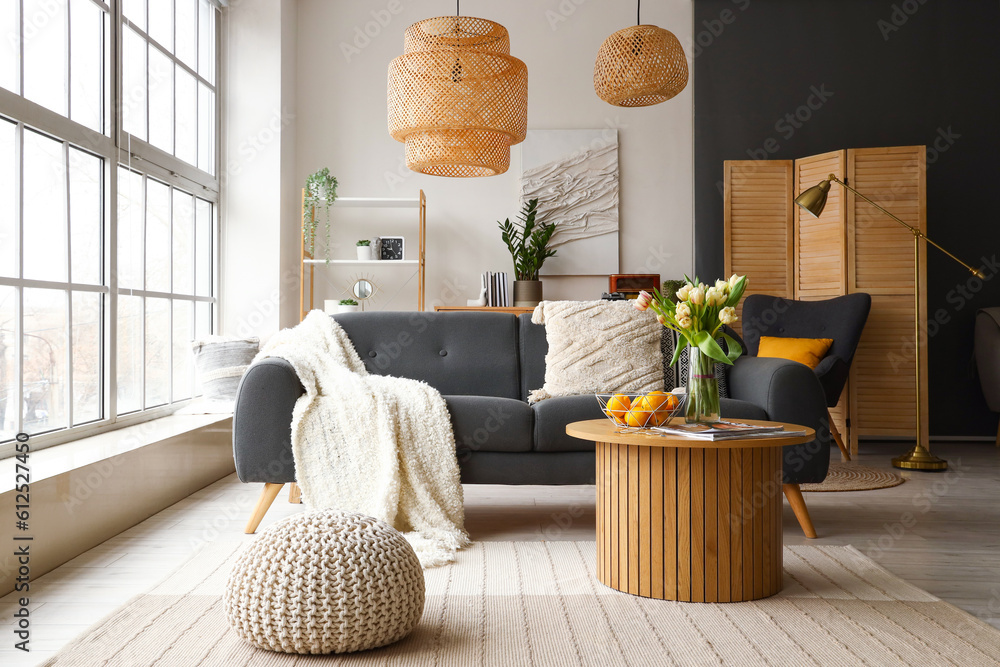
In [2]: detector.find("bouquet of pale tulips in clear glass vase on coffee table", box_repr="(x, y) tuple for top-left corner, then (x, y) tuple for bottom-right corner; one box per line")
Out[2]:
(633, 274), (747, 423)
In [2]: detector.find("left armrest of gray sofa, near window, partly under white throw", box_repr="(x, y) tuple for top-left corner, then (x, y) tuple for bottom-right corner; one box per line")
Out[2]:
(233, 358), (305, 484)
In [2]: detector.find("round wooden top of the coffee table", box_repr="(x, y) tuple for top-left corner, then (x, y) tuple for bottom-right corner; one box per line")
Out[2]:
(566, 419), (816, 449)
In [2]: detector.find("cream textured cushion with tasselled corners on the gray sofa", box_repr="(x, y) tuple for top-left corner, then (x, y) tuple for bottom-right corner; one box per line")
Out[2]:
(528, 301), (663, 403)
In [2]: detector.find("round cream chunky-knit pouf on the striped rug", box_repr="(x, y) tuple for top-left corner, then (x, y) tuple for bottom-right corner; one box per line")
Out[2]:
(224, 510), (424, 653)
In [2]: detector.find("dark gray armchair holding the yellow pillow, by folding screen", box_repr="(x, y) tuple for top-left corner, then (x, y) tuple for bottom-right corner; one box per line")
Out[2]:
(743, 292), (872, 461)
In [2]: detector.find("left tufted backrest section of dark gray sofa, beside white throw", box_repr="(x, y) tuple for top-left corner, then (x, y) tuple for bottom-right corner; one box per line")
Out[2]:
(333, 312), (524, 399)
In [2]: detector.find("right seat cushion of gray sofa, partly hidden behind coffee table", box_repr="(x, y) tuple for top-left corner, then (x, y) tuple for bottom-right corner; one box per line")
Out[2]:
(531, 394), (767, 452)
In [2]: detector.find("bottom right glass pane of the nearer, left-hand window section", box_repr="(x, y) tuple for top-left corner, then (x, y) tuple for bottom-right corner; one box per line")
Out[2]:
(71, 292), (103, 425)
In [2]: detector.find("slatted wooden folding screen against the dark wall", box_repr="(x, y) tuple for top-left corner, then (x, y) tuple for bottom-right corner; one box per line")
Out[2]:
(725, 146), (928, 455)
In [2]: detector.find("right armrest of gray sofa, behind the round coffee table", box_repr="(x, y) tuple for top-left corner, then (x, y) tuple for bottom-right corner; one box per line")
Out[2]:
(729, 357), (830, 484)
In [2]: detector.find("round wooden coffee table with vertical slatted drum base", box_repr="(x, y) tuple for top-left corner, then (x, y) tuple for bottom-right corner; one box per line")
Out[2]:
(566, 419), (816, 602)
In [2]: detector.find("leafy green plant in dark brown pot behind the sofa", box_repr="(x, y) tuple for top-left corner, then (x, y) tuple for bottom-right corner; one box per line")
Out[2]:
(497, 199), (556, 307)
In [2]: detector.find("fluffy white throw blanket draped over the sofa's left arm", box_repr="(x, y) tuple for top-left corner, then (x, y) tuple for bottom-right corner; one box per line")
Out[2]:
(257, 310), (469, 567)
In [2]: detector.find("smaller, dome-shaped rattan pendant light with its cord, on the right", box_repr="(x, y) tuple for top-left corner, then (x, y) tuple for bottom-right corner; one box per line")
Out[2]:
(594, 0), (688, 107)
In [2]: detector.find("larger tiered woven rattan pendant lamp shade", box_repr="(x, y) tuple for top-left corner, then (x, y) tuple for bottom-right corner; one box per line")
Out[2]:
(388, 16), (528, 177)
